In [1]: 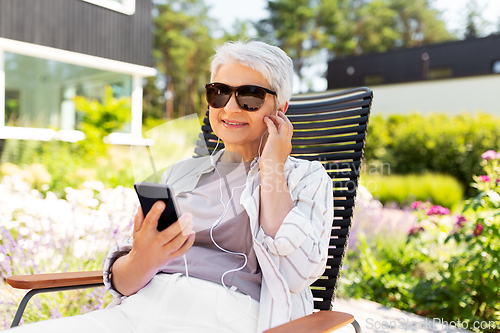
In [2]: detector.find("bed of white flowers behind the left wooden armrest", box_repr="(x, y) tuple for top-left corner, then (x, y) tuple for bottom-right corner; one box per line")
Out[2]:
(0, 176), (138, 328)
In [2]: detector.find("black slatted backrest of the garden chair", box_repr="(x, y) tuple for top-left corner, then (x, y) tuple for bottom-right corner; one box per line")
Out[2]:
(195, 87), (373, 310)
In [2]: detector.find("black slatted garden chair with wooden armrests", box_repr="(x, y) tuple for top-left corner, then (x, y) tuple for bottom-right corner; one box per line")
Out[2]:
(7, 87), (373, 333)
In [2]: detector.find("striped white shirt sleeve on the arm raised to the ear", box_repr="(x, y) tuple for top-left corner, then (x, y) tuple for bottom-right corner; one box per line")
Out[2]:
(259, 162), (333, 293)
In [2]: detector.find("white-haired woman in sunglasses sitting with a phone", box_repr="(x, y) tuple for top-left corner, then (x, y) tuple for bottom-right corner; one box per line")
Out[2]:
(10, 41), (333, 332)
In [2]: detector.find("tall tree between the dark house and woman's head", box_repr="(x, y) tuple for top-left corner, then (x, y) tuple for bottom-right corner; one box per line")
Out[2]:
(154, 0), (214, 119)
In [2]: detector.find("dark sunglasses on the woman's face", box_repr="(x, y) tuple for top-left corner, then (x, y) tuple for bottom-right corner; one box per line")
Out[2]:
(205, 82), (276, 111)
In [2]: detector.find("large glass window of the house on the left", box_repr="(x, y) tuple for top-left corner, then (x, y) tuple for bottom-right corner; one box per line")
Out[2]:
(4, 52), (132, 132)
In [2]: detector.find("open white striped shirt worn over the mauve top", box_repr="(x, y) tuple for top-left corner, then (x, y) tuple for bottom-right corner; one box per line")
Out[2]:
(104, 152), (333, 332)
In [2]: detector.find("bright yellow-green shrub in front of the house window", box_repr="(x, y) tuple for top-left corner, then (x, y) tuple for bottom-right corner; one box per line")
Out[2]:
(74, 86), (131, 158)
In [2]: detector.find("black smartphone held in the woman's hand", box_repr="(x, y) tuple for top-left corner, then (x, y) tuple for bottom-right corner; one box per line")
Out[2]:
(134, 183), (181, 231)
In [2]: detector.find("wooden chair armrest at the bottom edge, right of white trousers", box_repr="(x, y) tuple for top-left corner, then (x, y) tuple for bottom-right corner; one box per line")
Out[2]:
(264, 311), (354, 333)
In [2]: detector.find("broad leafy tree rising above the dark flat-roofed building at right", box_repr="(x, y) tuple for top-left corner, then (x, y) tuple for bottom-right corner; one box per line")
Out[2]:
(317, 0), (454, 56)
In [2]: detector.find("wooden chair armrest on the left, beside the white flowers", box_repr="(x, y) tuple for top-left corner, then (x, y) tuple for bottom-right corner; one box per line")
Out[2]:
(7, 271), (103, 289)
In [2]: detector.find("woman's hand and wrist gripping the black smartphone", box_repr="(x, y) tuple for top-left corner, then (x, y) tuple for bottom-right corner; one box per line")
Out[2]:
(112, 201), (195, 296)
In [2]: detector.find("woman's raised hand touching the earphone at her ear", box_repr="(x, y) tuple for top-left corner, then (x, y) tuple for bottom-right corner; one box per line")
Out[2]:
(260, 111), (293, 169)
